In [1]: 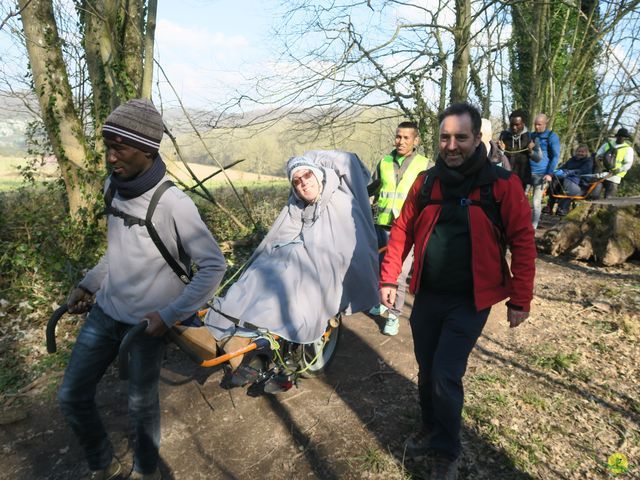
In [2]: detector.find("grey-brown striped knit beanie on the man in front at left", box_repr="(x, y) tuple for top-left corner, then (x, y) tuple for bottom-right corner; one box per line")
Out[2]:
(102, 98), (164, 153)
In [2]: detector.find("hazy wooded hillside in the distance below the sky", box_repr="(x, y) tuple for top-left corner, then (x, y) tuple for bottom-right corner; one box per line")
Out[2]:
(0, 93), (410, 176)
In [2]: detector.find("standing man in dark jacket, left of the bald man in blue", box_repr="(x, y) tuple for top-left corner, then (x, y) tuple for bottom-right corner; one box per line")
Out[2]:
(498, 110), (533, 188)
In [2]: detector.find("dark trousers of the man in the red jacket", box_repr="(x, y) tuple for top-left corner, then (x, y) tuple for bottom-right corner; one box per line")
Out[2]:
(409, 291), (491, 459)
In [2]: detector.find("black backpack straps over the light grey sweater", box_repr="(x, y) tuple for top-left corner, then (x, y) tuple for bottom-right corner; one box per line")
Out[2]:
(104, 180), (193, 285)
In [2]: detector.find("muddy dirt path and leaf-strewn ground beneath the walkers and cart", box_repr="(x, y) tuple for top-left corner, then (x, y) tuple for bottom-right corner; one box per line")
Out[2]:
(0, 251), (640, 479)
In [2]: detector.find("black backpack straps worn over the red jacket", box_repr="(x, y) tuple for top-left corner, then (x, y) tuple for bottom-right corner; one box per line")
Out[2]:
(417, 165), (512, 253)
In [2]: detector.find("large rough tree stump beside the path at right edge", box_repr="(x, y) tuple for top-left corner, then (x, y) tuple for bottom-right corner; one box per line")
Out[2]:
(538, 197), (640, 266)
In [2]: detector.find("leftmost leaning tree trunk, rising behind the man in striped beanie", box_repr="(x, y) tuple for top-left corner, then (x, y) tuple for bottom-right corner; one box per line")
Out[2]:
(20, 0), (99, 217)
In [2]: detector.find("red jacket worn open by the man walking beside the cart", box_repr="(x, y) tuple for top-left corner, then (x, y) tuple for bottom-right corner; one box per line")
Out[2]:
(380, 168), (536, 312)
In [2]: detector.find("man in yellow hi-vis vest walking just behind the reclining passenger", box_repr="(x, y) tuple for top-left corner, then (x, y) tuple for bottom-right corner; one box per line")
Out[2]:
(367, 122), (429, 335)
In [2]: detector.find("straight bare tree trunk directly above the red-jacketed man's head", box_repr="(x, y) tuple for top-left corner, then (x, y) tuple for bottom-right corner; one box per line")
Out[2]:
(450, 0), (471, 103)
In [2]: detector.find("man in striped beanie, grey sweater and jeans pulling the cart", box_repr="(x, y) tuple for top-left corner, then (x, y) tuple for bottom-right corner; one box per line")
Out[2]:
(58, 99), (226, 479)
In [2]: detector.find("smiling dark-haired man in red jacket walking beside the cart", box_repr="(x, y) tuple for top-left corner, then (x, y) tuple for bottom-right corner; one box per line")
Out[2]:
(380, 103), (536, 479)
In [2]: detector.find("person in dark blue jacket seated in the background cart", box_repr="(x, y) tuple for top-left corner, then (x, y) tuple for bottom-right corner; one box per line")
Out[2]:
(545, 145), (593, 216)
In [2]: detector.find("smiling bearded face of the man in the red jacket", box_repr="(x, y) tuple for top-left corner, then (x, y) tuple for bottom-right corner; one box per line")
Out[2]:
(440, 113), (482, 168)
